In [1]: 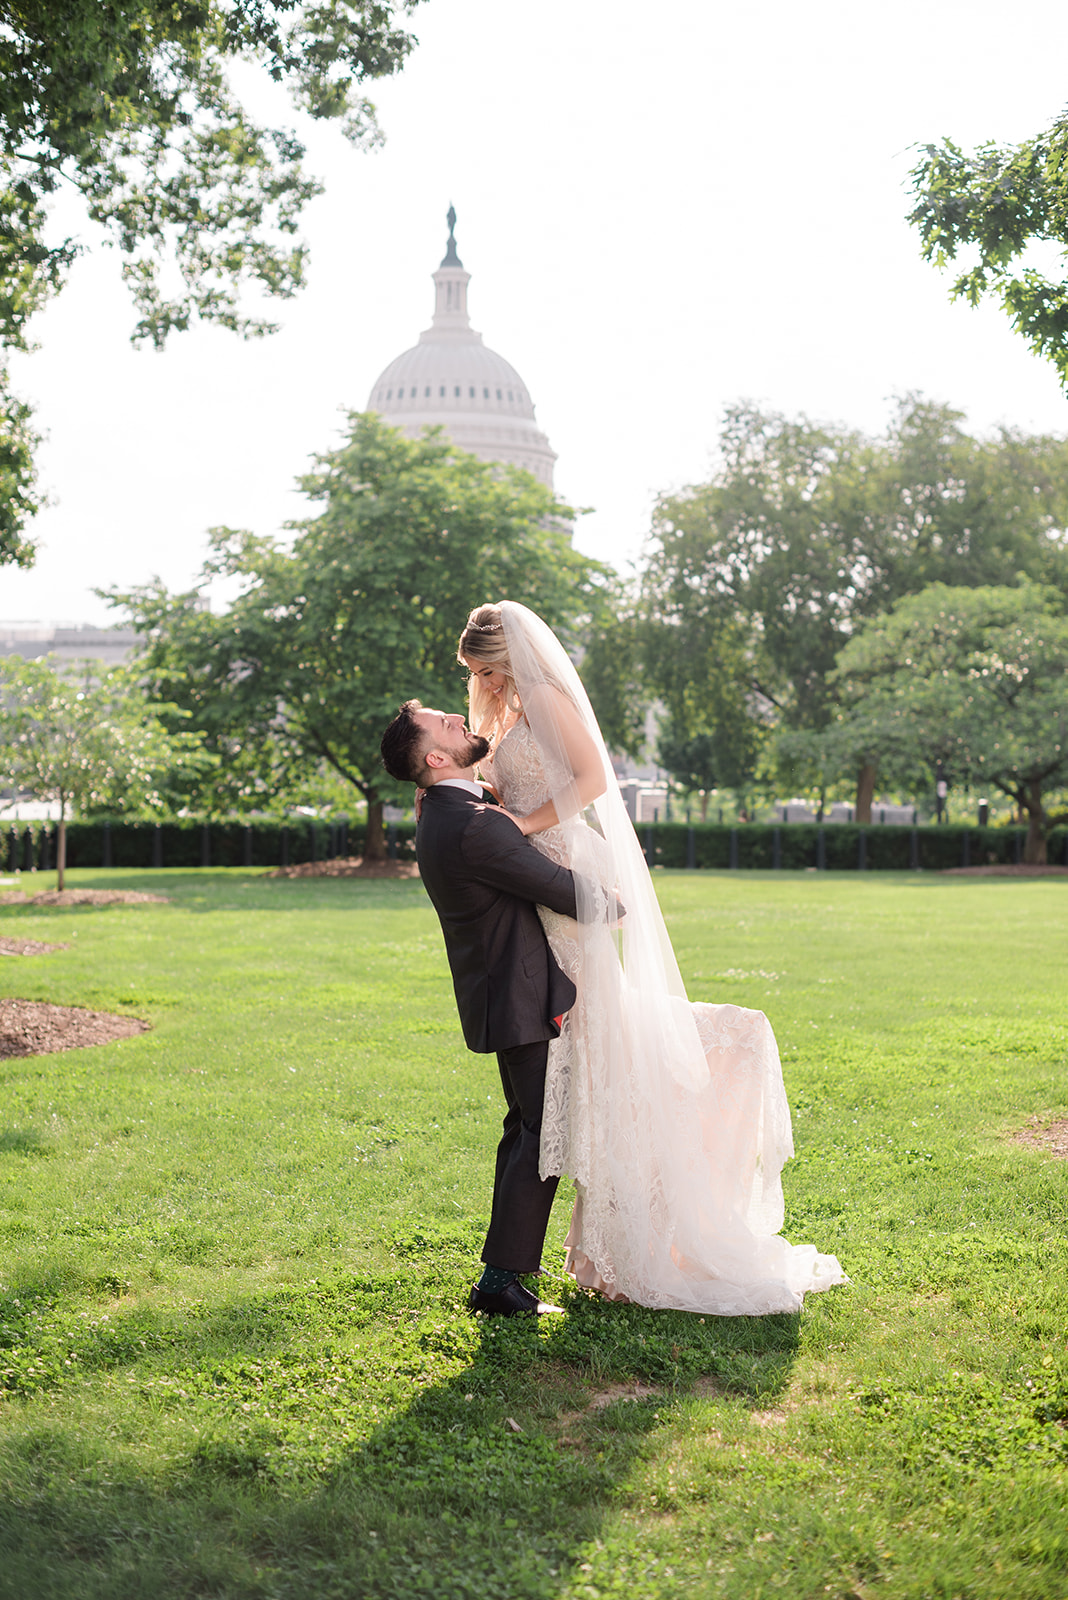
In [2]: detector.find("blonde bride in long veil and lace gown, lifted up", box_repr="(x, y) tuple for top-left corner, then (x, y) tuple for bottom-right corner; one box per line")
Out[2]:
(457, 600), (847, 1317)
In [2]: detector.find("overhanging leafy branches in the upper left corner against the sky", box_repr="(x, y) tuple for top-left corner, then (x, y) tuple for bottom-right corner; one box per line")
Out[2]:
(0, 0), (417, 565)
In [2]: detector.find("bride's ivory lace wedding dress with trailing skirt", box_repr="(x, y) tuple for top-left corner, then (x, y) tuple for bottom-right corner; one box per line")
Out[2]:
(491, 716), (847, 1317)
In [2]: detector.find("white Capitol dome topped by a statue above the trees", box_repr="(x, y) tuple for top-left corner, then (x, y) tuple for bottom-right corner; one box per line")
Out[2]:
(368, 206), (556, 488)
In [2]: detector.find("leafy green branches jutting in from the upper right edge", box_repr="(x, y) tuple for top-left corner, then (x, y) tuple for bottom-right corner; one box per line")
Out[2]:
(908, 114), (1068, 387)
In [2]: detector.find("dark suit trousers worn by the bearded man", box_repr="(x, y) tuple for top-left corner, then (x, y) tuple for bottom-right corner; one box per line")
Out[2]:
(483, 1040), (560, 1272)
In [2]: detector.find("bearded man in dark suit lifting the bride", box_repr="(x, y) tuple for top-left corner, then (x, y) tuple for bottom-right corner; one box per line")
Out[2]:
(382, 701), (577, 1317)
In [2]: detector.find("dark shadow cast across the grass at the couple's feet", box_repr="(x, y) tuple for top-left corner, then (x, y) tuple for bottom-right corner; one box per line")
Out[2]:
(0, 1269), (798, 1600)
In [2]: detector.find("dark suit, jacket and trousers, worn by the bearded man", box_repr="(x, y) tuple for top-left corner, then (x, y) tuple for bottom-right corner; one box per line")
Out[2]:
(416, 784), (576, 1272)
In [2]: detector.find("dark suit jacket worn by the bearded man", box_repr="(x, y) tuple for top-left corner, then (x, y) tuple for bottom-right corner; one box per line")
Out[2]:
(416, 784), (576, 1051)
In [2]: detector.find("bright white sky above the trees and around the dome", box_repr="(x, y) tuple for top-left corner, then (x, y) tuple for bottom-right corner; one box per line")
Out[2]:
(0, 0), (1068, 621)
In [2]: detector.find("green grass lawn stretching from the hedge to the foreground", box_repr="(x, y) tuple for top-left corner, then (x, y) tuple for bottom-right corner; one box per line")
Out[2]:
(0, 872), (1068, 1600)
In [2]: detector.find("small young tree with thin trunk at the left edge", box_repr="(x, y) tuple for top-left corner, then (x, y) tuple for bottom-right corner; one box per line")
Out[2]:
(0, 656), (200, 888)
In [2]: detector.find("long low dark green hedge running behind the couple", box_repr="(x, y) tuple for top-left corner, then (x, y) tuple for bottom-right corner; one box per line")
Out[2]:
(0, 818), (1068, 872)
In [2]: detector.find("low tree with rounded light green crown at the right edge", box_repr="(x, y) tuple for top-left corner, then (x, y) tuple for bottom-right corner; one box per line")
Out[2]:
(836, 582), (1068, 862)
